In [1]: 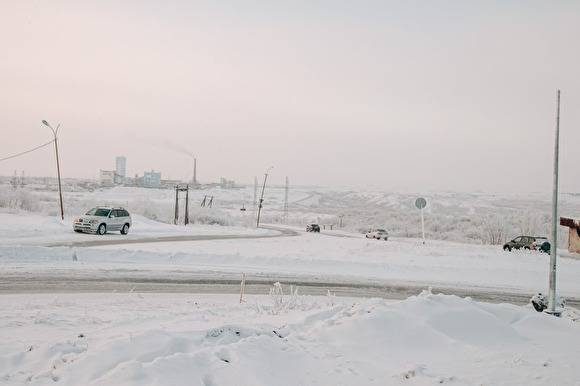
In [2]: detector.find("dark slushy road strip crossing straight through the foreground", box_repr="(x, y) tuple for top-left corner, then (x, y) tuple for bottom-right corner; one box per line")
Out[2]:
(0, 272), (580, 308)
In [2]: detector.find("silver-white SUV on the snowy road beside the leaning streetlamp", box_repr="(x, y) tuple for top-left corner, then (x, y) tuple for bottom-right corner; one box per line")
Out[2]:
(73, 206), (132, 235)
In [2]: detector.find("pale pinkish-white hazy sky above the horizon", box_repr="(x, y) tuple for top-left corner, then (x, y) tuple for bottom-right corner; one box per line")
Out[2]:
(0, 0), (580, 192)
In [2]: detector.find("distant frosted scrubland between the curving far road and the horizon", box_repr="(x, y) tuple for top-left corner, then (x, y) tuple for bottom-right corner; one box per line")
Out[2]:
(0, 183), (580, 246)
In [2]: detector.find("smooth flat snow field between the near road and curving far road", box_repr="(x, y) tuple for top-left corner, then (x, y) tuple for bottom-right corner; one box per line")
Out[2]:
(0, 214), (580, 298)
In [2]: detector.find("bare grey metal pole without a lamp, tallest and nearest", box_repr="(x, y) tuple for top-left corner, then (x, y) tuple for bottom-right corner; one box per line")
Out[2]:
(548, 90), (560, 314)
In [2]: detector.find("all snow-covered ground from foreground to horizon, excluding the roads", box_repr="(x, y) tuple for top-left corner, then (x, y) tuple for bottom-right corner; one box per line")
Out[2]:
(0, 188), (580, 386)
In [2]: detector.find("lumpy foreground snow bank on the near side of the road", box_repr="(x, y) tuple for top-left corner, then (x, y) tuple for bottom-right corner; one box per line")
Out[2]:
(0, 293), (580, 386)
